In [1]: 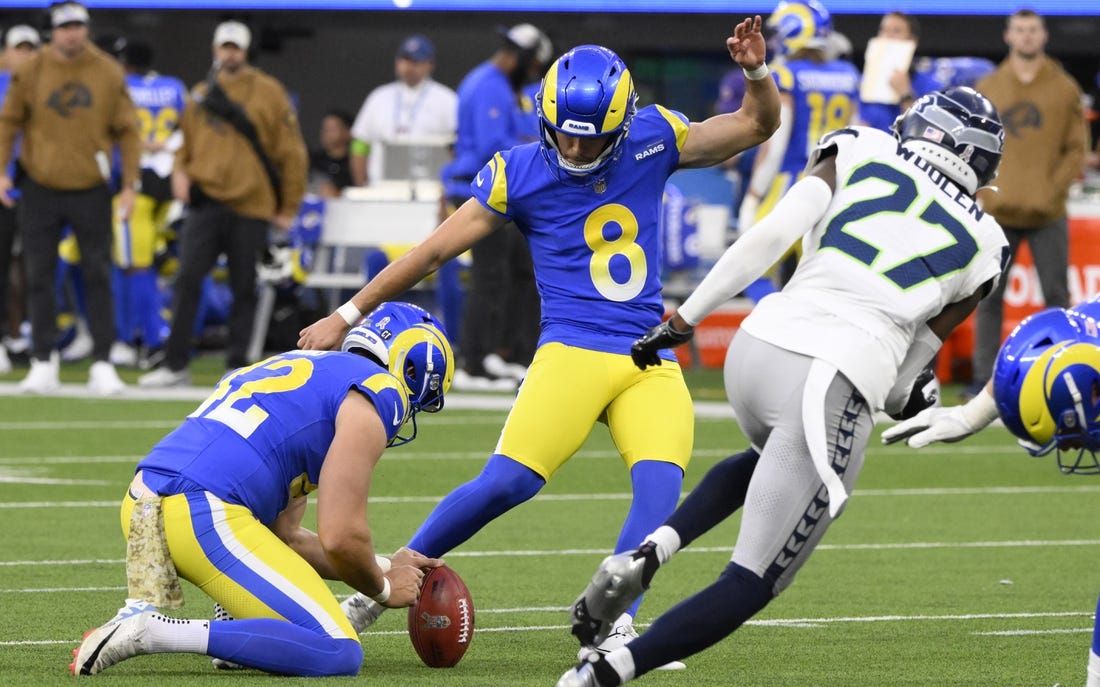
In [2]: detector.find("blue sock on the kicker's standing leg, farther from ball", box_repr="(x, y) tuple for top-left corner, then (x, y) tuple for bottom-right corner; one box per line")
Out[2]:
(615, 461), (684, 616)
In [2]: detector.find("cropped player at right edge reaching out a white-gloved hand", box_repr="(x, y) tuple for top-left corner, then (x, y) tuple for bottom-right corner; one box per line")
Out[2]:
(882, 297), (1100, 687)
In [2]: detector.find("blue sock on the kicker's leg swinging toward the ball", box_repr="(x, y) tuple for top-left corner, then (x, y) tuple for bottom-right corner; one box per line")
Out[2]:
(409, 453), (546, 558)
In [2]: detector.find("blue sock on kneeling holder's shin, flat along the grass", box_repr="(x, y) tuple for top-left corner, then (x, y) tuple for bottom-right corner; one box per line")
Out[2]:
(207, 618), (363, 677)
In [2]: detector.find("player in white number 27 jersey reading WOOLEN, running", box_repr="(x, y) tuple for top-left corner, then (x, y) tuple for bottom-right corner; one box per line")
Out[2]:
(558, 89), (1005, 687)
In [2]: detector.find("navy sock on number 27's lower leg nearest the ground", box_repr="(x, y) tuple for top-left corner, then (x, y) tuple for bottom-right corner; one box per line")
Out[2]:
(628, 563), (773, 677)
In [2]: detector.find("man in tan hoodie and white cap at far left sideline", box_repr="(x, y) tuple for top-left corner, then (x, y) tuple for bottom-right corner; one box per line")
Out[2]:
(0, 2), (141, 395)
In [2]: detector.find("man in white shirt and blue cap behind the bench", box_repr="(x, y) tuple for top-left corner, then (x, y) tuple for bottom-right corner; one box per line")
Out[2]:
(351, 35), (458, 186)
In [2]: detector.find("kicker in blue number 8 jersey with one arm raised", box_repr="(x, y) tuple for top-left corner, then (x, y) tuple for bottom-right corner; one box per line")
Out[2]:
(298, 16), (779, 667)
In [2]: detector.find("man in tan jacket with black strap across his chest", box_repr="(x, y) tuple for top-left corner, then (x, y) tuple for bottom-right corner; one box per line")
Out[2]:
(139, 21), (308, 387)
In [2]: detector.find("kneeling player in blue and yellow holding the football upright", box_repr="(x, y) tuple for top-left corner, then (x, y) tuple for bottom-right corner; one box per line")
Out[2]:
(69, 303), (454, 676)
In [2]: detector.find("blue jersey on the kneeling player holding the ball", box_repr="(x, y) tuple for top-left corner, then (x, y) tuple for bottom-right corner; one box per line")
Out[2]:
(138, 351), (409, 524)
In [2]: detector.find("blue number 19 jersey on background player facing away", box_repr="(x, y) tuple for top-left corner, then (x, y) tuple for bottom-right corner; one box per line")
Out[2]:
(772, 59), (859, 178)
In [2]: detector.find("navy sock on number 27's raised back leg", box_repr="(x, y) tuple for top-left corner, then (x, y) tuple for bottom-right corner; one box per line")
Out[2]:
(664, 448), (760, 547)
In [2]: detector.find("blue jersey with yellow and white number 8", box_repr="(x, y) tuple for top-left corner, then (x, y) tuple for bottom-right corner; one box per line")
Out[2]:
(470, 106), (688, 359)
